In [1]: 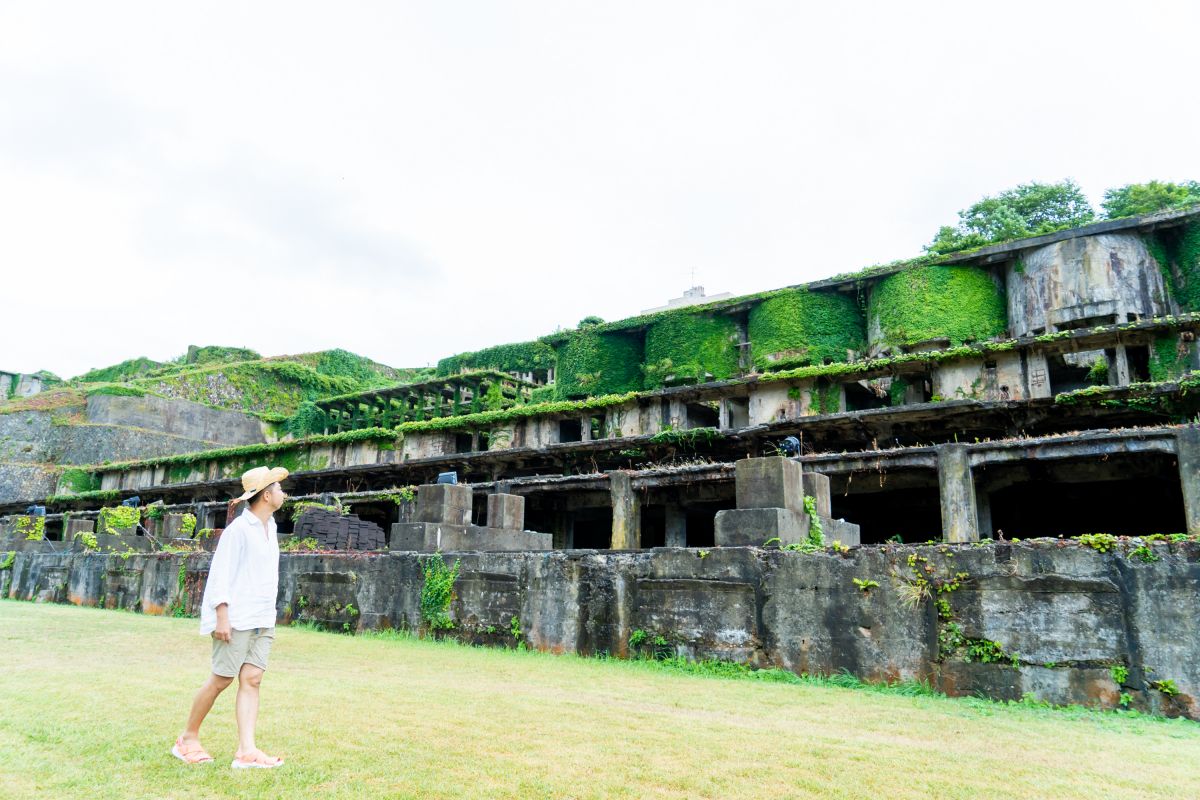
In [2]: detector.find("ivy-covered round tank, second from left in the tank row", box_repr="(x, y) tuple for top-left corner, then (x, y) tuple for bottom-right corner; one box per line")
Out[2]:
(644, 312), (738, 389)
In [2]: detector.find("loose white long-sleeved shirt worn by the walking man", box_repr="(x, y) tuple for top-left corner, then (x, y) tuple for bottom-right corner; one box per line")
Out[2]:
(200, 509), (280, 633)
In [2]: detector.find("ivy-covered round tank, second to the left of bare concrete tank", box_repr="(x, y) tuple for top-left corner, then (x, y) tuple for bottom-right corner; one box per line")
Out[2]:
(748, 289), (866, 371)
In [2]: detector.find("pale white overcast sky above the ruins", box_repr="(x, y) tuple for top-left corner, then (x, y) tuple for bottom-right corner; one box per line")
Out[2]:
(0, 0), (1200, 377)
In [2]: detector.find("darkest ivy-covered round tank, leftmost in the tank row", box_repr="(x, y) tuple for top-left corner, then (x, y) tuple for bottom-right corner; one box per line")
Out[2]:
(554, 329), (642, 399)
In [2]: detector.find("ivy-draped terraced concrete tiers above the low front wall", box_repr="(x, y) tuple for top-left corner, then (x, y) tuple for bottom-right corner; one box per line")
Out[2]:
(0, 203), (1200, 714)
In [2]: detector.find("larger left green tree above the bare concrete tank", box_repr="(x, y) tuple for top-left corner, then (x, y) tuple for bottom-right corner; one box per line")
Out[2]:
(925, 179), (1096, 253)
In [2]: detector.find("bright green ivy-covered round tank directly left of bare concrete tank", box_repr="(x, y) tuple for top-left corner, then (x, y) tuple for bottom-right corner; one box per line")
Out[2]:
(868, 266), (1008, 348)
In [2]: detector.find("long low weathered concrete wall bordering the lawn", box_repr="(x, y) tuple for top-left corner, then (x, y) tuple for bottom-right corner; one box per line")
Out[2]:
(0, 541), (1200, 720)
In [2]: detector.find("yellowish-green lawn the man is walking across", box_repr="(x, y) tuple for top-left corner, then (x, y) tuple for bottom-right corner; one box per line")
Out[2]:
(0, 601), (1200, 800)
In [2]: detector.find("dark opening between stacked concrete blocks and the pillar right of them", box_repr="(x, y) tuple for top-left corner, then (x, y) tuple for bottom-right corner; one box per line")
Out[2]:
(830, 482), (942, 545)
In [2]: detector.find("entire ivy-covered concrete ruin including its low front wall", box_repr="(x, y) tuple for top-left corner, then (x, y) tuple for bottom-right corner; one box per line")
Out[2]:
(0, 210), (1200, 716)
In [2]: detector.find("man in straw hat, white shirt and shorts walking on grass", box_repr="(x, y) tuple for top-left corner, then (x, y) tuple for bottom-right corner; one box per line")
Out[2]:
(170, 467), (288, 769)
